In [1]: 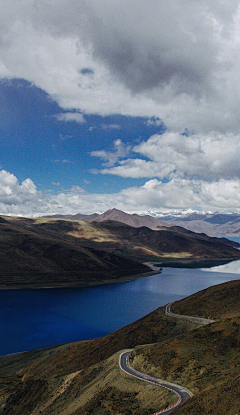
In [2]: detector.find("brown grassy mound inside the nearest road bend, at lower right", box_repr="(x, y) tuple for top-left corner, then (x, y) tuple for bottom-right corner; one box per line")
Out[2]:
(132, 318), (240, 415)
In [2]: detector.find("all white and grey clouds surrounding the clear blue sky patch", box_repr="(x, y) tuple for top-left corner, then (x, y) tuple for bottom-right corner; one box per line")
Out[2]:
(0, 0), (240, 215)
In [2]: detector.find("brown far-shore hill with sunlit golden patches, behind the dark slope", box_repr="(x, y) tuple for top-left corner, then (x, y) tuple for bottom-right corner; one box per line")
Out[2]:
(3, 218), (240, 262)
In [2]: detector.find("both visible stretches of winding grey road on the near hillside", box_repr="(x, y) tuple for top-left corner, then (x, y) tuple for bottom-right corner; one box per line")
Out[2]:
(119, 301), (215, 415)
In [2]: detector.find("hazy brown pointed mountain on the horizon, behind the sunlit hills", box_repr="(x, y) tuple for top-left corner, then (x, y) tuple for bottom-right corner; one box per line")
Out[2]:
(47, 209), (171, 229)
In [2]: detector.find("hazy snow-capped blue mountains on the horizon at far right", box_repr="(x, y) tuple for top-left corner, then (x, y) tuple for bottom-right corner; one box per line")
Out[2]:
(161, 213), (240, 236)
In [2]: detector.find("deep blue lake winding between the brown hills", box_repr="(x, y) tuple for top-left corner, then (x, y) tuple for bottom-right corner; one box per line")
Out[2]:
(0, 261), (240, 355)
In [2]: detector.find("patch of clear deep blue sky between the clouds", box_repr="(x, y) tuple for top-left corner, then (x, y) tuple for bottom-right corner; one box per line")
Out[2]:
(0, 79), (160, 193)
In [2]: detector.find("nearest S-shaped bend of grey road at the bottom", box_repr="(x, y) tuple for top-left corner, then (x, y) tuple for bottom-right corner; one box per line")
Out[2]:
(119, 349), (193, 415)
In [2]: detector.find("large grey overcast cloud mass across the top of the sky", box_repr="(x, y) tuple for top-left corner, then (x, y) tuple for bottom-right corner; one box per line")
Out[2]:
(0, 0), (240, 132)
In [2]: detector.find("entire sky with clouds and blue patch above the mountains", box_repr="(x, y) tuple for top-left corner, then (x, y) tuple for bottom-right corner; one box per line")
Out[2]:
(0, 0), (240, 217)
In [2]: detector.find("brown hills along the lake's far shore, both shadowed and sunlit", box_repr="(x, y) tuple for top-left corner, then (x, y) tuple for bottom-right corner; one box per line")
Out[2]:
(0, 214), (240, 287)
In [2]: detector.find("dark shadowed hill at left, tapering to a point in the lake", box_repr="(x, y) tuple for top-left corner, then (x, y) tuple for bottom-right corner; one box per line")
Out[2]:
(0, 219), (149, 287)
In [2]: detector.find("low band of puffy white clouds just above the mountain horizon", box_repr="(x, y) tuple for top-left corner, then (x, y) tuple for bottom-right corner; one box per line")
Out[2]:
(0, 170), (240, 216)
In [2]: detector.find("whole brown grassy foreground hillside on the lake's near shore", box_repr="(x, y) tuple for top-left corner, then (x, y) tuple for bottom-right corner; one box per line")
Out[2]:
(0, 281), (240, 415)
